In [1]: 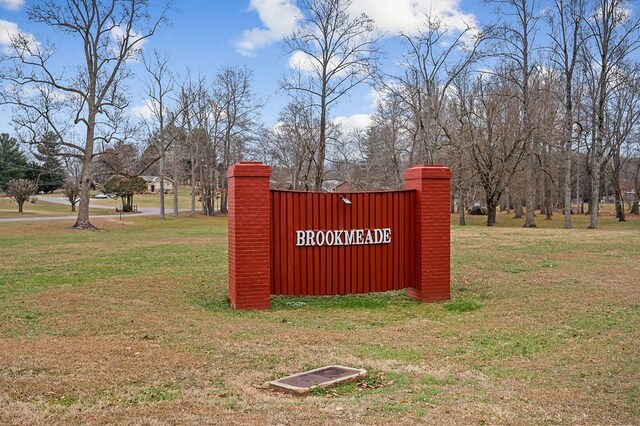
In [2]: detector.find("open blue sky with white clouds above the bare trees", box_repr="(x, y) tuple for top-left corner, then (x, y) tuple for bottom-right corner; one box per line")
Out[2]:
(0, 0), (492, 134)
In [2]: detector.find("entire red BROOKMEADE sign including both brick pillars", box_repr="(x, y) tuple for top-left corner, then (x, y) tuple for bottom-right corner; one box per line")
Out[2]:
(227, 162), (451, 309)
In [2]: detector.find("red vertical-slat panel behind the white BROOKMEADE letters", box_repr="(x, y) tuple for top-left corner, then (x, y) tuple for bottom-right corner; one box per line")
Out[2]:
(271, 191), (416, 295)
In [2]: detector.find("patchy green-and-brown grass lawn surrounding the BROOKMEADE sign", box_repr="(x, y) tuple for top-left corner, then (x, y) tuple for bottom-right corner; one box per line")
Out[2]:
(0, 213), (640, 425)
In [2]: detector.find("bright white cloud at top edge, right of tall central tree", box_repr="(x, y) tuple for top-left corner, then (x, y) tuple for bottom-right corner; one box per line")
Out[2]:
(351, 0), (476, 35)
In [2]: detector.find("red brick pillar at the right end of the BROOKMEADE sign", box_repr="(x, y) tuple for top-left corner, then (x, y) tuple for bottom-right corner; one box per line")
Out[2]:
(404, 165), (451, 302)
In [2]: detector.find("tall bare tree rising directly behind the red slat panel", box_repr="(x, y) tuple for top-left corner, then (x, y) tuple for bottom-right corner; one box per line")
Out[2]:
(282, 0), (377, 191)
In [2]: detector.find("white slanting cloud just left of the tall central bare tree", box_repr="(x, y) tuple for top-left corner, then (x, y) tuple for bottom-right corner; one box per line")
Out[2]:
(235, 0), (302, 55)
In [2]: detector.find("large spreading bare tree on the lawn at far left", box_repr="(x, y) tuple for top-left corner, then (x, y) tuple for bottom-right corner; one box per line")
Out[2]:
(0, 0), (168, 229)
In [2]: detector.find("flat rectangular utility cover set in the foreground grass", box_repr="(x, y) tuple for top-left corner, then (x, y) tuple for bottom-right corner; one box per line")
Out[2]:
(269, 365), (367, 395)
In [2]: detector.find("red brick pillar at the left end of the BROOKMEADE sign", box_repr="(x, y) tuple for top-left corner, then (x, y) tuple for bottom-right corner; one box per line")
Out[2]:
(227, 162), (271, 309)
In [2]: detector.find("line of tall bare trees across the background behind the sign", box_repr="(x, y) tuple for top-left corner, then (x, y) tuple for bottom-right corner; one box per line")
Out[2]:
(0, 0), (640, 228)
